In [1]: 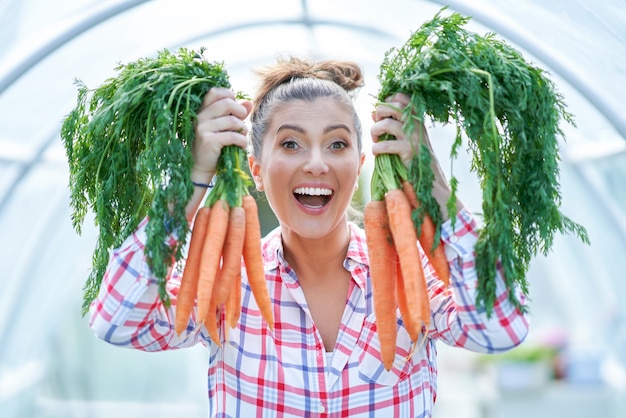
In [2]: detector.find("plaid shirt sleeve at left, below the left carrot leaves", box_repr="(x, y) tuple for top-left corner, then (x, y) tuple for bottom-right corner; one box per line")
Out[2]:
(89, 219), (202, 351)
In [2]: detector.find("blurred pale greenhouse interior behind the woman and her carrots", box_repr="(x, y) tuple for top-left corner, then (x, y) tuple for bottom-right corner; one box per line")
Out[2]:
(0, 0), (626, 418)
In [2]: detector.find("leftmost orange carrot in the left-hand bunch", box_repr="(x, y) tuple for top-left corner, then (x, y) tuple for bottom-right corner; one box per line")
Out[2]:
(174, 207), (210, 335)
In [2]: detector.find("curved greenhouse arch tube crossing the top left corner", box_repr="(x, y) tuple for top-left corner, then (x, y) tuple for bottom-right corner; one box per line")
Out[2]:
(0, 0), (149, 95)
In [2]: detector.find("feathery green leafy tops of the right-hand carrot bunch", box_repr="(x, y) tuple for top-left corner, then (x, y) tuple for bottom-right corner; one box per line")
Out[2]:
(378, 8), (588, 314)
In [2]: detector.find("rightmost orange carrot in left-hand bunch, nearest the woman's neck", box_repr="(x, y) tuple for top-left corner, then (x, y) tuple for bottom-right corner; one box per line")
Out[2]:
(242, 195), (274, 330)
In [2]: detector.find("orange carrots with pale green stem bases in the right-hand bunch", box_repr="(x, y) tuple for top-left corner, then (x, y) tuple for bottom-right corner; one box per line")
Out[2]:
(363, 137), (450, 370)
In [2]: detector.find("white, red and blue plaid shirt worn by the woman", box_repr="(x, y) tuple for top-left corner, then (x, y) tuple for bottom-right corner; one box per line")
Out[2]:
(91, 210), (528, 417)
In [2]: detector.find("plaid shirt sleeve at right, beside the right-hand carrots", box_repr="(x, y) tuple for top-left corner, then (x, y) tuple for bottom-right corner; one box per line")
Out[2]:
(424, 209), (529, 353)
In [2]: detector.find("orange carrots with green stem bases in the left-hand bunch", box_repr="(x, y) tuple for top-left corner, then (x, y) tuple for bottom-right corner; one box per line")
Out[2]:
(174, 146), (274, 345)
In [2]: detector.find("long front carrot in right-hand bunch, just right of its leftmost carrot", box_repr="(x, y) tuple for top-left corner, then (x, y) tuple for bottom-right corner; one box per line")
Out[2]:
(385, 189), (430, 325)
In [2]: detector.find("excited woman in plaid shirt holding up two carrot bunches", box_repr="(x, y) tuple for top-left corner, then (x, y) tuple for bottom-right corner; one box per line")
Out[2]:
(91, 59), (528, 417)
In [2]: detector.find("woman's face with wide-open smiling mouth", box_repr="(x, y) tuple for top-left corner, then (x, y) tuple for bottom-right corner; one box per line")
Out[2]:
(250, 98), (364, 239)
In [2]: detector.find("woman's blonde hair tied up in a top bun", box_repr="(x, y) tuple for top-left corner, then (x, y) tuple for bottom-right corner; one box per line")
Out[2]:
(250, 57), (364, 158)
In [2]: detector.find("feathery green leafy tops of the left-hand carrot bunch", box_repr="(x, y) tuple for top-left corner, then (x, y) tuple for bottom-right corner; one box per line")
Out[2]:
(61, 48), (230, 314)
